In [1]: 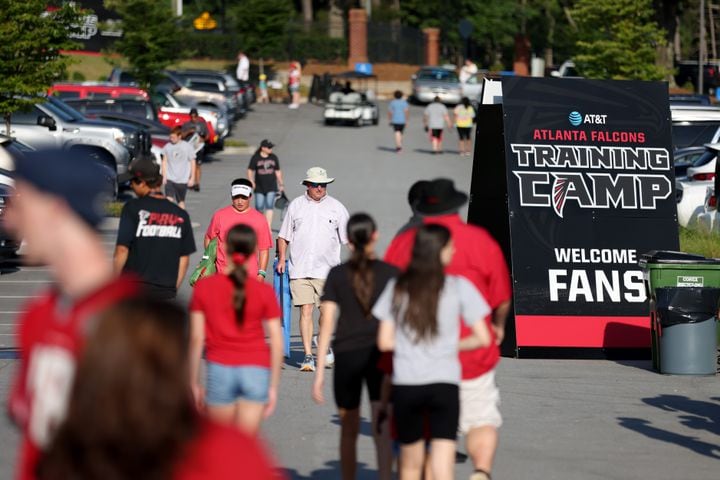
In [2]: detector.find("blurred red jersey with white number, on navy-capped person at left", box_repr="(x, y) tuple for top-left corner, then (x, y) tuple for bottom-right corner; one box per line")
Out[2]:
(8, 277), (139, 479)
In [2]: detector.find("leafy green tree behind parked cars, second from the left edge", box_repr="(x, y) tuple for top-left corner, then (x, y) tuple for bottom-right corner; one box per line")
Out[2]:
(105, 0), (187, 88)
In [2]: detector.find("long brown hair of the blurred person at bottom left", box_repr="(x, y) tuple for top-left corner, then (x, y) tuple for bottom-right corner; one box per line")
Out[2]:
(37, 299), (199, 480)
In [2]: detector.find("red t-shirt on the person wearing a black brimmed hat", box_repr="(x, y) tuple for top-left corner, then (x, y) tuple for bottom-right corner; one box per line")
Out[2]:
(385, 214), (512, 380)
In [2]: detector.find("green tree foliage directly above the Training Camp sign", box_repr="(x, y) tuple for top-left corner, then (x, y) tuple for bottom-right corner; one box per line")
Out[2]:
(573, 0), (667, 80)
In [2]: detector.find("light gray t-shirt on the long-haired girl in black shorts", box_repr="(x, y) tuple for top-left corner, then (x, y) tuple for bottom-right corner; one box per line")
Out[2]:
(372, 275), (490, 385)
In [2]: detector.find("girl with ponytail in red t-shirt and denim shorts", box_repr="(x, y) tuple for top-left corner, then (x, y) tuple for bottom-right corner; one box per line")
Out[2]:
(190, 225), (283, 435)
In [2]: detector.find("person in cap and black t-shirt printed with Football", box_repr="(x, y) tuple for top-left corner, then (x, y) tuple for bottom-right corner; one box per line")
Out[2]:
(114, 157), (195, 299)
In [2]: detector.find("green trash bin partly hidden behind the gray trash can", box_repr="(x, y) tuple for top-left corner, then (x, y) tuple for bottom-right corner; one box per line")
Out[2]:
(638, 250), (720, 372)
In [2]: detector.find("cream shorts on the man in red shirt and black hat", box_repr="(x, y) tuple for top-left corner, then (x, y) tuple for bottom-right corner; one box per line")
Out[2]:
(459, 369), (502, 434)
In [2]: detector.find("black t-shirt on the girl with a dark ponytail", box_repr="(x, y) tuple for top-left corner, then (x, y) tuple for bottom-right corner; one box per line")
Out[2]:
(322, 260), (399, 352)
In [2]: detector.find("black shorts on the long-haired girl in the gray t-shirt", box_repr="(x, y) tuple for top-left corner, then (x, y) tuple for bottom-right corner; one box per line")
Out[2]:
(393, 383), (460, 444)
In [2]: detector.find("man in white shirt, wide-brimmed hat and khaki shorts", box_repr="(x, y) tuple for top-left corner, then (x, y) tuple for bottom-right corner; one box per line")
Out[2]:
(278, 167), (349, 372)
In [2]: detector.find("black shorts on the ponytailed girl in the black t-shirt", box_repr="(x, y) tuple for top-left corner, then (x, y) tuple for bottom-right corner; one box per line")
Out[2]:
(333, 347), (383, 410)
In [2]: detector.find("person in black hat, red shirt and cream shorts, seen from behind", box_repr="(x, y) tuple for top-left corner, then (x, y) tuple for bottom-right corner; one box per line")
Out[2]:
(385, 178), (512, 480)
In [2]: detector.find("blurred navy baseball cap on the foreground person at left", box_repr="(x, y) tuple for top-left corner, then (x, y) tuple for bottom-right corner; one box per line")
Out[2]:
(15, 149), (115, 227)
